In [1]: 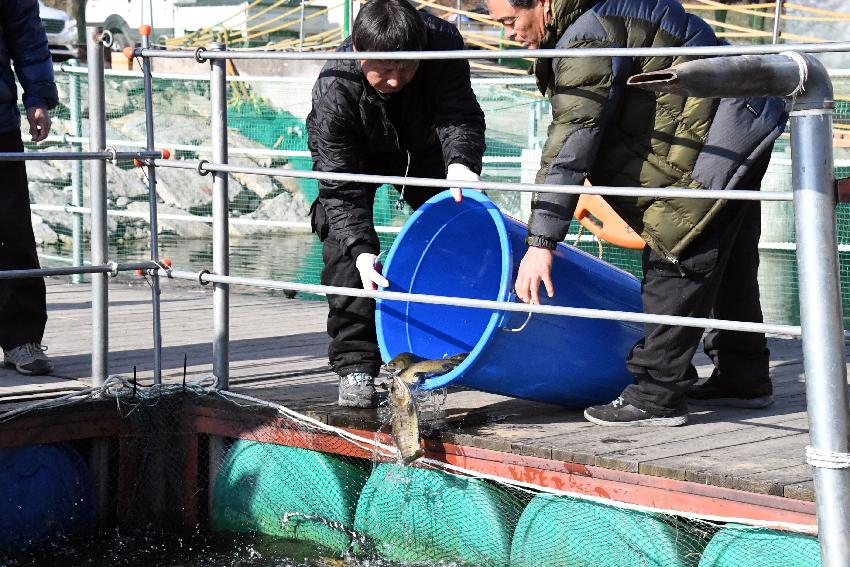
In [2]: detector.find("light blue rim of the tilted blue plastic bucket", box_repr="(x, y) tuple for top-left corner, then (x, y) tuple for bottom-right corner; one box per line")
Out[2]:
(375, 189), (513, 390)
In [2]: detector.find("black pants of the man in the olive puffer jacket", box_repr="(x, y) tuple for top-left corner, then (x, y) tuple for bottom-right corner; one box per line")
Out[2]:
(623, 155), (773, 415)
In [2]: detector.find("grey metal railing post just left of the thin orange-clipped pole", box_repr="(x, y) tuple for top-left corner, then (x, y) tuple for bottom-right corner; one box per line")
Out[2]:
(86, 27), (109, 386)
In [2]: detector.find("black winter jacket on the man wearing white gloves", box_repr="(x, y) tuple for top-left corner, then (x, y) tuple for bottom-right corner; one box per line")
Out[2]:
(307, 13), (484, 258)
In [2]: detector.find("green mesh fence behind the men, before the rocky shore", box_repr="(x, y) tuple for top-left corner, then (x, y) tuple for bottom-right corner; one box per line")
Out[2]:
(27, 68), (850, 328)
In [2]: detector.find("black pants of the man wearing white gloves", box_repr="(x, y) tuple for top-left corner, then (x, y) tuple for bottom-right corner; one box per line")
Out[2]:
(316, 151), (445, 376)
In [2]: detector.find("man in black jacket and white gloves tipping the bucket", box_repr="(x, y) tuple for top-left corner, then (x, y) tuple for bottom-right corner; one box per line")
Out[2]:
(307, 0), (484, 407)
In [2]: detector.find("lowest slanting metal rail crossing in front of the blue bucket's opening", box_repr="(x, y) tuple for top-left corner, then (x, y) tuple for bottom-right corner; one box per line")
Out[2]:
(159, 270), (801, 337)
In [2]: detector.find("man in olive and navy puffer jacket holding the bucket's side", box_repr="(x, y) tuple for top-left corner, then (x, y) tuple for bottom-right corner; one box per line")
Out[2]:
(489, 0), (787, 426)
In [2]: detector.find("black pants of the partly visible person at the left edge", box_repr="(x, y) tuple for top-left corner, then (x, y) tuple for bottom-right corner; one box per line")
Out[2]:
(0, 130), (47, 350)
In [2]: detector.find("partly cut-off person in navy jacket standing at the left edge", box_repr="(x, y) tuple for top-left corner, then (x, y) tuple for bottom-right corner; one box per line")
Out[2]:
(0, 0), (58, 380)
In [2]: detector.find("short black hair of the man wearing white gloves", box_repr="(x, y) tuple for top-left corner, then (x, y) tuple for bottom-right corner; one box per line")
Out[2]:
(351, 0), (428, 51)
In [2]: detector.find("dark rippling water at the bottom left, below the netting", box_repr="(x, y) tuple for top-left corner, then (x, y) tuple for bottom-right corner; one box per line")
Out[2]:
(0, 530), (404, 567)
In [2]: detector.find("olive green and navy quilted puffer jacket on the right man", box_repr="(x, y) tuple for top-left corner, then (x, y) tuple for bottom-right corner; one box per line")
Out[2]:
(529, 0), (788, 262)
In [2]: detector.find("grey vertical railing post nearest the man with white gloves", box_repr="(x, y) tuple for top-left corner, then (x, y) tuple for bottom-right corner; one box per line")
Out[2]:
(209, 42), (230, 389)
